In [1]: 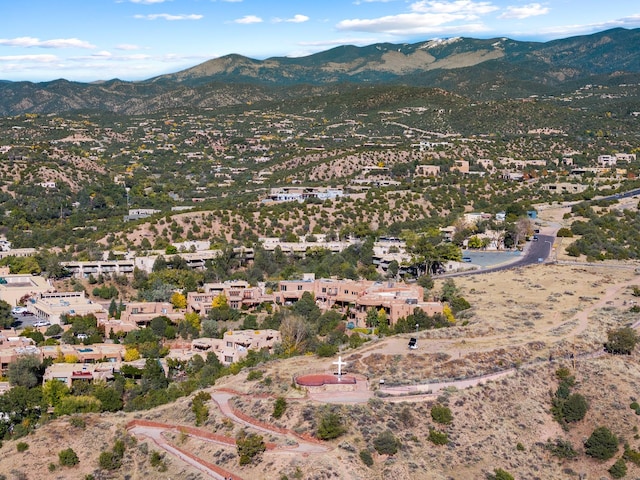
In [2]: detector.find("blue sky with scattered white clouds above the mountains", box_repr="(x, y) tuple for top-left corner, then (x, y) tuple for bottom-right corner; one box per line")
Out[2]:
(0, 0), (640, 82)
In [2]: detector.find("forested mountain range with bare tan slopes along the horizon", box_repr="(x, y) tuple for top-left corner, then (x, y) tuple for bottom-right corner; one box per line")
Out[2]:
(0, 28), (640, 116)
